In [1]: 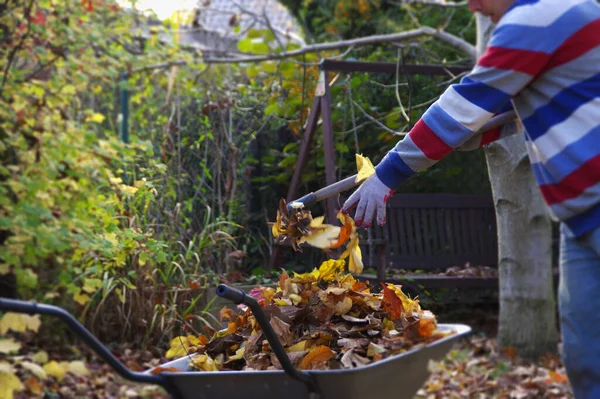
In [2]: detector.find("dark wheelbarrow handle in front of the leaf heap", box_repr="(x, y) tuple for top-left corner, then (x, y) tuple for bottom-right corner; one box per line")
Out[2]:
(217, 284), (320, 397)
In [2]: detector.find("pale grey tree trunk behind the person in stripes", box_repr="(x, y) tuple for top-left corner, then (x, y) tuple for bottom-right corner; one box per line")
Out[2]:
(477, 15), (558, 357)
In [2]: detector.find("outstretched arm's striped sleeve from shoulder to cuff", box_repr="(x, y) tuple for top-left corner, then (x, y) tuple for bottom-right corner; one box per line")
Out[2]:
(376, 20), (553, 188)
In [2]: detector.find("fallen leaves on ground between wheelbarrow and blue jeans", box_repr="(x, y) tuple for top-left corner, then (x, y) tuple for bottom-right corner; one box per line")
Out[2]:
(416, 336), (573, 399)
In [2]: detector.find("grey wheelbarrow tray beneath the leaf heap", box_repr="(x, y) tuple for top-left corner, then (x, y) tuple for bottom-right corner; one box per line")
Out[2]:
(148, 324), (471, 399)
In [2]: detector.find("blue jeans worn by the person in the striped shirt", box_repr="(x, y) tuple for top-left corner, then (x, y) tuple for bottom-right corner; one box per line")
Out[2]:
(558, 226), (600, 399)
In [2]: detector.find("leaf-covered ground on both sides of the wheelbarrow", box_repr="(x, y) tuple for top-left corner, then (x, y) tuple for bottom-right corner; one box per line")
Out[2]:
(0, 334), (573, 399)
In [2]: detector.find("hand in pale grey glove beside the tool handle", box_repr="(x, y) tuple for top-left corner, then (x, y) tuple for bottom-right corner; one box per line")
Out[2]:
(342, 173), (394, 228)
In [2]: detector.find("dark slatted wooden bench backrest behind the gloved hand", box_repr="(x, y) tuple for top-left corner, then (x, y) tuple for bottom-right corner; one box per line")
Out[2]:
(361, 194), (498, 270)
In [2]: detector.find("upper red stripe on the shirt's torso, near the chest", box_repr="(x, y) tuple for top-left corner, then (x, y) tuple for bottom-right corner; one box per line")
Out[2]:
(544, 19), (600, 70)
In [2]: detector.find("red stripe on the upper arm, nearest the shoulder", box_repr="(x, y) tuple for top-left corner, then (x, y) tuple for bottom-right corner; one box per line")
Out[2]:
(477, 47), (550, 76)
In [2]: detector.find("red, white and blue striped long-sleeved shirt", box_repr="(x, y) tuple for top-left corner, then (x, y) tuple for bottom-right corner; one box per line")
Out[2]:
(376, 0), (600, 236)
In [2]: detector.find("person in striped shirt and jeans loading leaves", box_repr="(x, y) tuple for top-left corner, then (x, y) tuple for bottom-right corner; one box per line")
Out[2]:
(342, 0), (600, 398)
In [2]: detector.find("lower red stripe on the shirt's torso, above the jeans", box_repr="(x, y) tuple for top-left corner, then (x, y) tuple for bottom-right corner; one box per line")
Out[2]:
(540, 155), (600, 205)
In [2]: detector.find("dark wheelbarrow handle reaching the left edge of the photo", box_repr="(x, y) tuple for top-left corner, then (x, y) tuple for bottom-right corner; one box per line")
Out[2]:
(0, 298), (181, 398)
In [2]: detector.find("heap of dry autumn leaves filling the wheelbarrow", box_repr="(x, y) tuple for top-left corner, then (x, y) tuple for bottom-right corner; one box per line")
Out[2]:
(166, 260), (444, 371)
